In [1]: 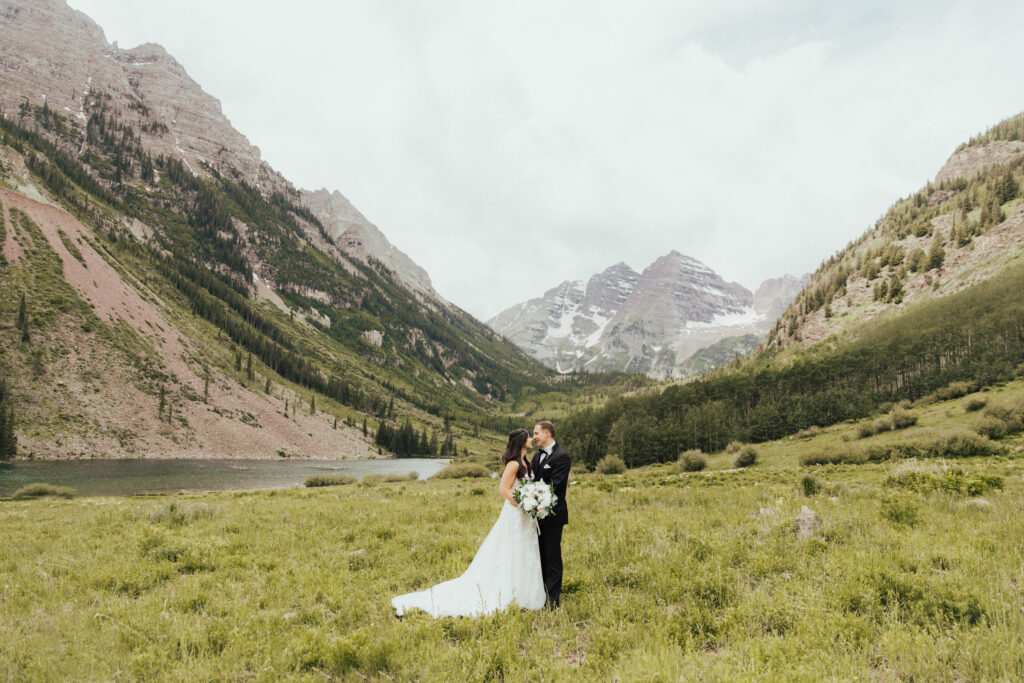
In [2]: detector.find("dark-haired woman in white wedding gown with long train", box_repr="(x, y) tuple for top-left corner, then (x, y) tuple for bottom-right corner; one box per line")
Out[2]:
(391, 429), (546, 616)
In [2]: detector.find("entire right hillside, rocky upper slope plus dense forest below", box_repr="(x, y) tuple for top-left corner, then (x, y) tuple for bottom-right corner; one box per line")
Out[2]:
(559, 114), (1024, 466)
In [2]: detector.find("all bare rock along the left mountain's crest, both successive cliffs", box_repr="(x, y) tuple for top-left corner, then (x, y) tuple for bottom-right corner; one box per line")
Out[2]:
(0, 0), (442, 301)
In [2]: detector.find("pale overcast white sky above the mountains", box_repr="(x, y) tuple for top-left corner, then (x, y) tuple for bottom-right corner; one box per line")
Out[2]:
(70, 0), (1024, 319)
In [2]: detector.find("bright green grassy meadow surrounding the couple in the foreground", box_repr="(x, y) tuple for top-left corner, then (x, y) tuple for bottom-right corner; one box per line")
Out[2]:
(0, 382), (1024, 681)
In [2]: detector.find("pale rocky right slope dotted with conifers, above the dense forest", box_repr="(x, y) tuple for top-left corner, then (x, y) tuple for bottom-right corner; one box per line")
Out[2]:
(769, 114), (1024, 350)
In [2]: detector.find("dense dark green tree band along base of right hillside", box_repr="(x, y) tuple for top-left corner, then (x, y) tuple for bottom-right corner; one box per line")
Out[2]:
(560, 266), (1024, 466)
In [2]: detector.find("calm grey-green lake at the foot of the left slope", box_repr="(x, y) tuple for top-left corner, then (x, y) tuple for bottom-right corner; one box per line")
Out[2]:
(0, 458), (450, 497)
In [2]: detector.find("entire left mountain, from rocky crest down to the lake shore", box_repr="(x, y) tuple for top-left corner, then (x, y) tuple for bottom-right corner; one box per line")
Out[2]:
(0, 0), (557, 457)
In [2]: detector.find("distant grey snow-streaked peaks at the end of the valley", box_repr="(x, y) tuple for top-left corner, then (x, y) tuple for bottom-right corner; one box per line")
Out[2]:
(487, 251), (804, 379)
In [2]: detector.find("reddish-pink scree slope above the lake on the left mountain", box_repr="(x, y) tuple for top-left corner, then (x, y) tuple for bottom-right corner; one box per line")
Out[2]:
(0, 188), (377, 459)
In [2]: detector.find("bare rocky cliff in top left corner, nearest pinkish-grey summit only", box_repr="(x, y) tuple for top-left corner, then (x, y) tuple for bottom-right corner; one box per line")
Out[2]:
(0, 0), (280, 189)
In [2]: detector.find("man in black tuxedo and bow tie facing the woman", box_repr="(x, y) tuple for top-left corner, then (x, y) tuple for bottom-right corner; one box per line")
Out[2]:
(530, 420), (571, 607)
